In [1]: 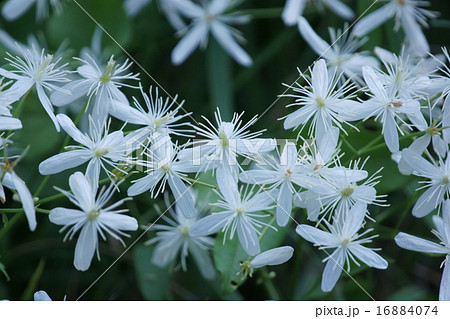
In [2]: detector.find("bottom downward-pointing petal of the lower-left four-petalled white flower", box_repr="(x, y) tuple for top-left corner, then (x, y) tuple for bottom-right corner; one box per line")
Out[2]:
(73, 222), (98, 271)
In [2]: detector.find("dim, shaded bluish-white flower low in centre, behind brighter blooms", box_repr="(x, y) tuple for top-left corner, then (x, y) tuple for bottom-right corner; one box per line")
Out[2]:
(146, 193), (216, 279)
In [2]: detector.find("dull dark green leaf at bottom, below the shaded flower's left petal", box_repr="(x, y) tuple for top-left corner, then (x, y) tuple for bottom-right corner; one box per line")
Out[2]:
(133, 245), (172, 300)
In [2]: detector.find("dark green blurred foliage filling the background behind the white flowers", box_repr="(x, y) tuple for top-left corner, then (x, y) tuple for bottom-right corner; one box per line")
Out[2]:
(0, 0), (450, 300)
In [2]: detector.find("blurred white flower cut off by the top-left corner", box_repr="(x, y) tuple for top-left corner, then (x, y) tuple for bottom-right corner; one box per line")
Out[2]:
(2, 0), (61, 21)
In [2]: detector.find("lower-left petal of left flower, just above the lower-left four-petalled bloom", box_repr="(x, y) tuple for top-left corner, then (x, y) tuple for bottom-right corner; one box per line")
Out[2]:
(39, 150), (91, 175)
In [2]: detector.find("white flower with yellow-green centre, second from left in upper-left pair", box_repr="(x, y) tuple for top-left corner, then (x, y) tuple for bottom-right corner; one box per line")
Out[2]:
(51, 56), (139, 125)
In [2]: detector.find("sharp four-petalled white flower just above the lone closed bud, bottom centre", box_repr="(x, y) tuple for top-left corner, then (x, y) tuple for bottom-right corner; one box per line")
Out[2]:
(189, 170), (276, 256)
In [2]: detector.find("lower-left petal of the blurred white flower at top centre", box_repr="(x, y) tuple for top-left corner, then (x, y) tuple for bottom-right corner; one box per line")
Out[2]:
(172, 23), (208, 65)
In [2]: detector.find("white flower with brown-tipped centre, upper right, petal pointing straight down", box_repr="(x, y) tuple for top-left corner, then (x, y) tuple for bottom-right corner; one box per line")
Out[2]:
(357, 67), (426, 153)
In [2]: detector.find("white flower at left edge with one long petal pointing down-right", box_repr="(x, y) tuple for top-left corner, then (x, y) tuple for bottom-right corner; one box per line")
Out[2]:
(0, 48), (69, 132)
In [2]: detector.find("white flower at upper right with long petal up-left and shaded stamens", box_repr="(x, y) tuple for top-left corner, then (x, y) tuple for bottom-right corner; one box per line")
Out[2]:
(298, 17), (379, 83)
